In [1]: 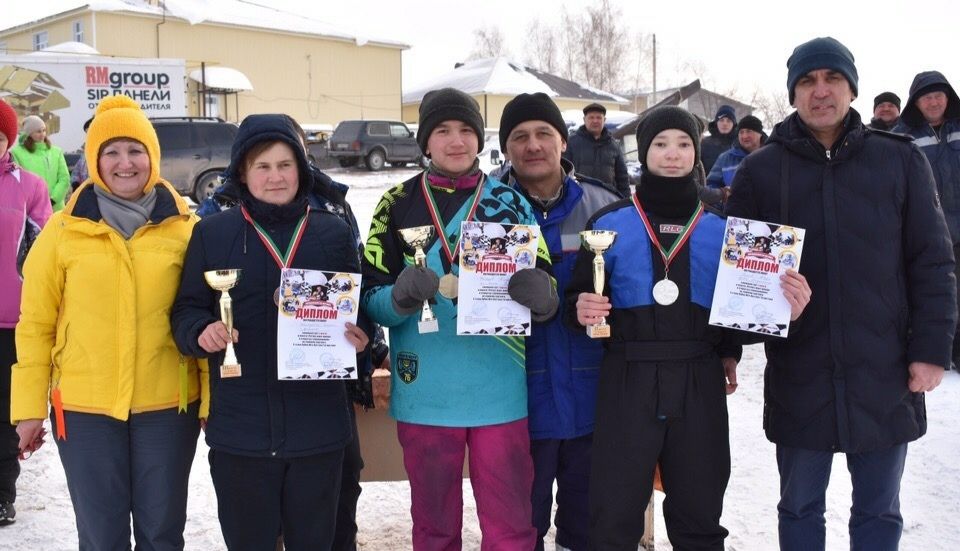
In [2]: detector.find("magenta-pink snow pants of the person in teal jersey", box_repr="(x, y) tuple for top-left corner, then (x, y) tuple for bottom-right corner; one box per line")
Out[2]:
(397, 418), (537, 551)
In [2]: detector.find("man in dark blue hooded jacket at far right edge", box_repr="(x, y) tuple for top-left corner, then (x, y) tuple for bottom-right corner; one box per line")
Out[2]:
(893, 71), (960, 369)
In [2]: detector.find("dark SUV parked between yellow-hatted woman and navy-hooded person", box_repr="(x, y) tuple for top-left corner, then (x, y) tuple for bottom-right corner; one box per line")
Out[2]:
(150, 117), (238, 204)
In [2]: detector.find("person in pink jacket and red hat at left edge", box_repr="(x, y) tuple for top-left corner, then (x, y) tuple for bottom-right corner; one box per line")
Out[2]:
(0, 100), (52, 527)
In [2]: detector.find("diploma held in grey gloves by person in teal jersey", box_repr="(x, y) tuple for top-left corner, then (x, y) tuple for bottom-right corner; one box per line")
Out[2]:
(457, 222), (540, 336)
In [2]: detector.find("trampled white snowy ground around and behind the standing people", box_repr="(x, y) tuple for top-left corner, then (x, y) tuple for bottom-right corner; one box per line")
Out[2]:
(0, 169), (960, 551)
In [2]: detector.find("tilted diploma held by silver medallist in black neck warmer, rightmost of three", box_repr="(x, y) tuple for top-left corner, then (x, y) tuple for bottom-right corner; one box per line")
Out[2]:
(710, 217), (804, 338)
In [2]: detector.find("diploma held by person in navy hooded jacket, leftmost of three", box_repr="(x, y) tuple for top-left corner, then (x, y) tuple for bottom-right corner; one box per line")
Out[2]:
(277, 268), (360, 380)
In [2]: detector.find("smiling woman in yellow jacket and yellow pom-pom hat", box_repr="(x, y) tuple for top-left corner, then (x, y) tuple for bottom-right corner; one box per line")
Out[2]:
(10, 96), (208, 550)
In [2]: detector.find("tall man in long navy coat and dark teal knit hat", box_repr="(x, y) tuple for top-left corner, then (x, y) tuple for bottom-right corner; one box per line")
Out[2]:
(726, 37), (957, 551)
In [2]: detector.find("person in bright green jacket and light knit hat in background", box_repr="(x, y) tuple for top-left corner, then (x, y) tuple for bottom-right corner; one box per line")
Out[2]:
(10, 115), (70, 211)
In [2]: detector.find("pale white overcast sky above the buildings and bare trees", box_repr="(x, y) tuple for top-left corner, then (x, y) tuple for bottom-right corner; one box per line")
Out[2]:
(2, 0), (960, 118)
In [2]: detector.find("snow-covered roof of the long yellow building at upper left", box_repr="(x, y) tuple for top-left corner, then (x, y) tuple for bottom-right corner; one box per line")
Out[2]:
(4, 0), (409, 49)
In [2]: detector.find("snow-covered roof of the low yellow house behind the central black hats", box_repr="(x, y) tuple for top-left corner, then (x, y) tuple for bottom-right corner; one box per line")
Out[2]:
(403, 57), (629, 104)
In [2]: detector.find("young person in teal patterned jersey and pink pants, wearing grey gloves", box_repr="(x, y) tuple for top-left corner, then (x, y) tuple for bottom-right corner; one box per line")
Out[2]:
(362, 88), (559, 551)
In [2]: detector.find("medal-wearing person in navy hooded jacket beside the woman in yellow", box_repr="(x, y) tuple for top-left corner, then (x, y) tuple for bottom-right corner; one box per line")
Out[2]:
(171, 115), (368, 550)
